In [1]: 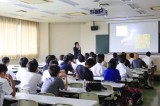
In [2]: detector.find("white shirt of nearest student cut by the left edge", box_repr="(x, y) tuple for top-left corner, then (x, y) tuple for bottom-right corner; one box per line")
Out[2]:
(0, 77), (13, 95)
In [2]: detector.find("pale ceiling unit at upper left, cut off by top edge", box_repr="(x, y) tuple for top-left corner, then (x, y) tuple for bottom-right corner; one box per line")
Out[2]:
(19, 0), (51, 4)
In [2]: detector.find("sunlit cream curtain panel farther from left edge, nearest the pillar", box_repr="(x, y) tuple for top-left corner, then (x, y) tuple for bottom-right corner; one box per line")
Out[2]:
(20, 20), (38, 58)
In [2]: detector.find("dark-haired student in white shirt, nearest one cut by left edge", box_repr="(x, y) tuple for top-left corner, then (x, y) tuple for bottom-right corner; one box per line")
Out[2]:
(0, 64), (16, 96)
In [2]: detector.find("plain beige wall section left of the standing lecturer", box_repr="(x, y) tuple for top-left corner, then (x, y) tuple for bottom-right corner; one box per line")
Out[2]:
(49, 23), (81, 57)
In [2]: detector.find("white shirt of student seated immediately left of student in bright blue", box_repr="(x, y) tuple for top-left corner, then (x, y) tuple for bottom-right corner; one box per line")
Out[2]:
(90, 63), (106, 76)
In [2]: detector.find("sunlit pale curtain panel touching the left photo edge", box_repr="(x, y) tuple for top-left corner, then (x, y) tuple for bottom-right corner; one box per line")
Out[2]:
(0, 17), (18, 59)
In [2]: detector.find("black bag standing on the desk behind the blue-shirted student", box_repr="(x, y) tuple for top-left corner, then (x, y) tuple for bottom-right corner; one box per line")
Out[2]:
(86, 82), (104, 92)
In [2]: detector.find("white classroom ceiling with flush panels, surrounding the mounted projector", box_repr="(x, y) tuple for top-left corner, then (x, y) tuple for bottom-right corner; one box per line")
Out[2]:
(0, 0), (160, 22)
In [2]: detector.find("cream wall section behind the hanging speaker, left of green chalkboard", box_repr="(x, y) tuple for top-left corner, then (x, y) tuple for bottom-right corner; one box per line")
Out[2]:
(80, 22), (108, 54)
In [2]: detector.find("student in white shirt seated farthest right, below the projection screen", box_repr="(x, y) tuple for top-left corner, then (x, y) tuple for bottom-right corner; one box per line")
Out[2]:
(142, 52), (153, 68)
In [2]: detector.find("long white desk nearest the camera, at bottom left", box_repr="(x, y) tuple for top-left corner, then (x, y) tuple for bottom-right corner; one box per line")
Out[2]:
(4, 93), (97, 106)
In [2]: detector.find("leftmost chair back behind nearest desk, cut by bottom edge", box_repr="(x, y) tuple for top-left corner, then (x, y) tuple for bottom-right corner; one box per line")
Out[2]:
(18, 100), (38, 106)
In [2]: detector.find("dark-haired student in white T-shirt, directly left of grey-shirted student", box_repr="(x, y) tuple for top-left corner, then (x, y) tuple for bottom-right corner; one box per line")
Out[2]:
(20, 59), (42, 93)
